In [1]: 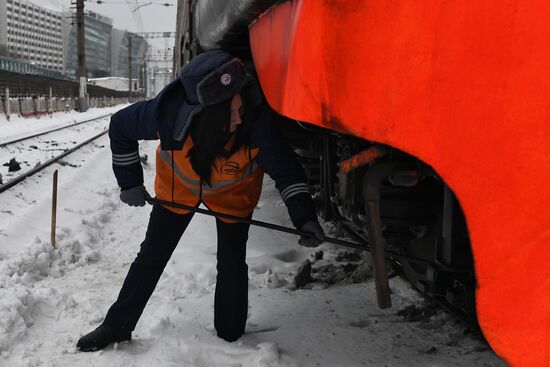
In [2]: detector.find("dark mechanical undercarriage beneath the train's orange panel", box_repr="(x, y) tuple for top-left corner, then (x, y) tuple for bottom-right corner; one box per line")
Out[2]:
(281, 119), (477, 327)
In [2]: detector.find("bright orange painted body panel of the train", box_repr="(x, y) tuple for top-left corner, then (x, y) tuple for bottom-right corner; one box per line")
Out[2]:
(250, 0), (550, 366)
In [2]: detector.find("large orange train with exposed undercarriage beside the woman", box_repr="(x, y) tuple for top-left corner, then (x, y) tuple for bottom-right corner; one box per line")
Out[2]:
(174, 0), (550, 366)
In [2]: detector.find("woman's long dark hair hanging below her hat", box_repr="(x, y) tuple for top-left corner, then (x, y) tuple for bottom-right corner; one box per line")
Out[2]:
(188, 95), (255, 185)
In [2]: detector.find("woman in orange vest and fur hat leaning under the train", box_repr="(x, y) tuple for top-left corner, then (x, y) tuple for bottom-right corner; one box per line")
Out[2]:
(77, 50), (324, 351)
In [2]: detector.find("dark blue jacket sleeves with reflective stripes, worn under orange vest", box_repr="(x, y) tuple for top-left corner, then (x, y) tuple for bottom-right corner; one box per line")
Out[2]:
(109, 79), (317, 228)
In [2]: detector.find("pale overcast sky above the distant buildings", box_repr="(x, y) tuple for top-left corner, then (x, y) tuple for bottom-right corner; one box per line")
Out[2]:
(30, 0), (177, 49)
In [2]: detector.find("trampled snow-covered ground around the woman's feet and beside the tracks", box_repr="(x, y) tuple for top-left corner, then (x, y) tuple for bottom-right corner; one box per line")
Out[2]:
(0, 109), (504, 367)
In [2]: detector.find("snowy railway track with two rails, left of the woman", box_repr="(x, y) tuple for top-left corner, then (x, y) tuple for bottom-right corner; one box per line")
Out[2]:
(0, 114), (110, 193)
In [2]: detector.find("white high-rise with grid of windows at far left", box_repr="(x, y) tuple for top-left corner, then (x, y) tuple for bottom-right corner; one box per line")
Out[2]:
(0, 0), (63, 71)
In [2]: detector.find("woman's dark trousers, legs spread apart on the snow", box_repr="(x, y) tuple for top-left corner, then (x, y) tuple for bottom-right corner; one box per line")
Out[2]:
(104, 205), (250, 341)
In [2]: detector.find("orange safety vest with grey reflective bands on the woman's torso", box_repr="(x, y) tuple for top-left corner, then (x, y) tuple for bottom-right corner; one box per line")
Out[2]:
(155, 136), (264, 223)
